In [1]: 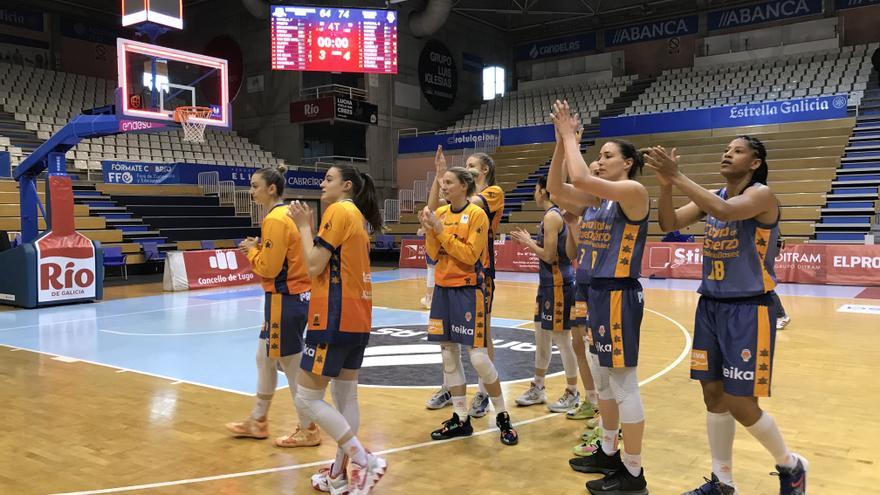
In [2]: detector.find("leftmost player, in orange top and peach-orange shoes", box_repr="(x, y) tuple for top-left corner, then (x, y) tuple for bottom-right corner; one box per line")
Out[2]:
(226, 166), (321, 447)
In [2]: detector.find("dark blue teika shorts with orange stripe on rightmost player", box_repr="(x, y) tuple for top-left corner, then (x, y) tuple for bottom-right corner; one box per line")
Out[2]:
(691, 293), (776, 397)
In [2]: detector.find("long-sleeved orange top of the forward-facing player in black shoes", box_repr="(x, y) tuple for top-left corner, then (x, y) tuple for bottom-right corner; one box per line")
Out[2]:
(425, 203), (492, 287)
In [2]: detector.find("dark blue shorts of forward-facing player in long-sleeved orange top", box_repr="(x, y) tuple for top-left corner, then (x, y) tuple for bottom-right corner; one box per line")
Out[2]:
(428, 286), (488, 348)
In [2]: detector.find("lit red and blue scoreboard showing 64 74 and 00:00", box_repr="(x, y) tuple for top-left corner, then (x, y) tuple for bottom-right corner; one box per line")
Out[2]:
(272, 5), (397, 74)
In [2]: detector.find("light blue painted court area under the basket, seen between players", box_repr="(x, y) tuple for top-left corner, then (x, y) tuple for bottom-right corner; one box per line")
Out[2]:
(0, 270), (530, 394)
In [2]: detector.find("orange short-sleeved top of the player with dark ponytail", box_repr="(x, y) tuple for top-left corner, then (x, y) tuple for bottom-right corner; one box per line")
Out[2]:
(306, 200), (373, 345)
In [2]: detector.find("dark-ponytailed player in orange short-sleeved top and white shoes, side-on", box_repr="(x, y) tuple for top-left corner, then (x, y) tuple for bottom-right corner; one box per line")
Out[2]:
(288, 165), (387, 494)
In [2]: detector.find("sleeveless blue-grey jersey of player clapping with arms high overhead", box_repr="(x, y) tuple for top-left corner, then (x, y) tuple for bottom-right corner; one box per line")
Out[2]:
(583, 199), (648, 279)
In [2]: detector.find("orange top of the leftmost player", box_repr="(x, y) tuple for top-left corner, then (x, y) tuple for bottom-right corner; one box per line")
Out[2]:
(247, 204), (312, 294)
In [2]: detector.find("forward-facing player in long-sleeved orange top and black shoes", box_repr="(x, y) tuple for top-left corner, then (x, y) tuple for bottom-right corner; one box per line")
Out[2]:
(419, 167), (518, 445)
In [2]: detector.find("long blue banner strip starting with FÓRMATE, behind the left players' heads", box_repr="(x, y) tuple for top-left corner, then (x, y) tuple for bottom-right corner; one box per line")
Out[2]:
(101, 160), (324, 189)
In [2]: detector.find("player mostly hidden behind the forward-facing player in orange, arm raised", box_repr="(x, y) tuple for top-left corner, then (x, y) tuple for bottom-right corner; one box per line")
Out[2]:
(428, 146), (504, 418)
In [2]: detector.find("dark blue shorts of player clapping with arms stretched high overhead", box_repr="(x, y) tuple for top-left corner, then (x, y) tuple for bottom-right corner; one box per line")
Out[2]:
(589, 278), (645, 368)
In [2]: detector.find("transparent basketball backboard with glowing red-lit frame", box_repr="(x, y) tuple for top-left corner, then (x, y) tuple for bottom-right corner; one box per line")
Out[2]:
(116, 38), (231, 127)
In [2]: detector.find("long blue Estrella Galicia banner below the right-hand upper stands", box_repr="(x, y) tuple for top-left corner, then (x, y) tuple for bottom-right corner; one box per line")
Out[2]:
(599, 95), (848, 137)
